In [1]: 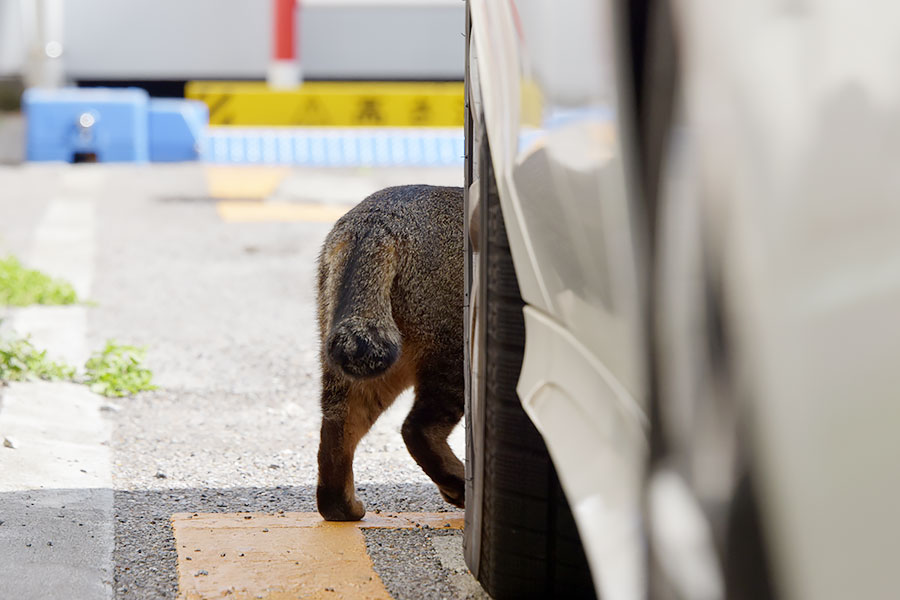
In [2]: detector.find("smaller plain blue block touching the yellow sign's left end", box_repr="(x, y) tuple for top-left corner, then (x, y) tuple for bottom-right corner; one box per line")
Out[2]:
(150, 99), (209, 162)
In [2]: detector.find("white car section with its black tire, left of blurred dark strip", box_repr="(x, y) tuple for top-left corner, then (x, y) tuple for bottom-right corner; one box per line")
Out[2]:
(465, 0), (648, 598)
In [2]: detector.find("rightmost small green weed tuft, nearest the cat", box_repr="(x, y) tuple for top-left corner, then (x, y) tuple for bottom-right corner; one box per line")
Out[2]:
(84, 340), (156, 397)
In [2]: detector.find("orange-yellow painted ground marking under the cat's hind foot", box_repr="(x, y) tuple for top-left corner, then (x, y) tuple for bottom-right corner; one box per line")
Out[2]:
(172, 513), (463, 600)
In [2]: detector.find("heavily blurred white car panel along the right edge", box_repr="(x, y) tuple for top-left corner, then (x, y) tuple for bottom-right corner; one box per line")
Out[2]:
(675, 0), (900, 600)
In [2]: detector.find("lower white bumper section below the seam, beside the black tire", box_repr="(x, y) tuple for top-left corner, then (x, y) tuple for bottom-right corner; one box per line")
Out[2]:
(518, 306), (646, 598)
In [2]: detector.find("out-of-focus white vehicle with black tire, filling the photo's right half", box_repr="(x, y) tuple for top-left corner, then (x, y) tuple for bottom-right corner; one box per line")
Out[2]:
(465, 0), (900, 600)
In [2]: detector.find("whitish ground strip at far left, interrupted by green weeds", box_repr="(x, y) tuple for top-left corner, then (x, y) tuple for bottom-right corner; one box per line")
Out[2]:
(0, 176), (115, 600)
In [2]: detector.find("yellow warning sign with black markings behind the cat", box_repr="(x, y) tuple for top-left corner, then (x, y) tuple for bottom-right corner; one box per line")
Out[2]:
(185, 81), (465, 127)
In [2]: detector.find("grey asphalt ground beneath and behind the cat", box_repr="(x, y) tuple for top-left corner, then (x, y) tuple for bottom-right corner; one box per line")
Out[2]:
(0, 164), (481, 600)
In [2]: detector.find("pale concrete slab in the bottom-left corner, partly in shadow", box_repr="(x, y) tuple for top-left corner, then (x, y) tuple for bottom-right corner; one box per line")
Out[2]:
(0, 382), (114, 600)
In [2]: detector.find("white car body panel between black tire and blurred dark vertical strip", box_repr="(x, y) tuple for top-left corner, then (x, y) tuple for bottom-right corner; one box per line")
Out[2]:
(470, 0), (647, 600)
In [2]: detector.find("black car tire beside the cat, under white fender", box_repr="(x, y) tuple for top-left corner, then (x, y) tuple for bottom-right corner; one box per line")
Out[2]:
(465, 124), (595, 599)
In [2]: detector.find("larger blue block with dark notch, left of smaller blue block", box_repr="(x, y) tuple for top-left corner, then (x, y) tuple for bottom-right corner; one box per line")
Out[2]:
(22, 88), (149, 162)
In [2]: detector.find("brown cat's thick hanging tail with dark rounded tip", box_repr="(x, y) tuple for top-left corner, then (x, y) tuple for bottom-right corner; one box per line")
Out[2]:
(319, 231), (401, 379)
